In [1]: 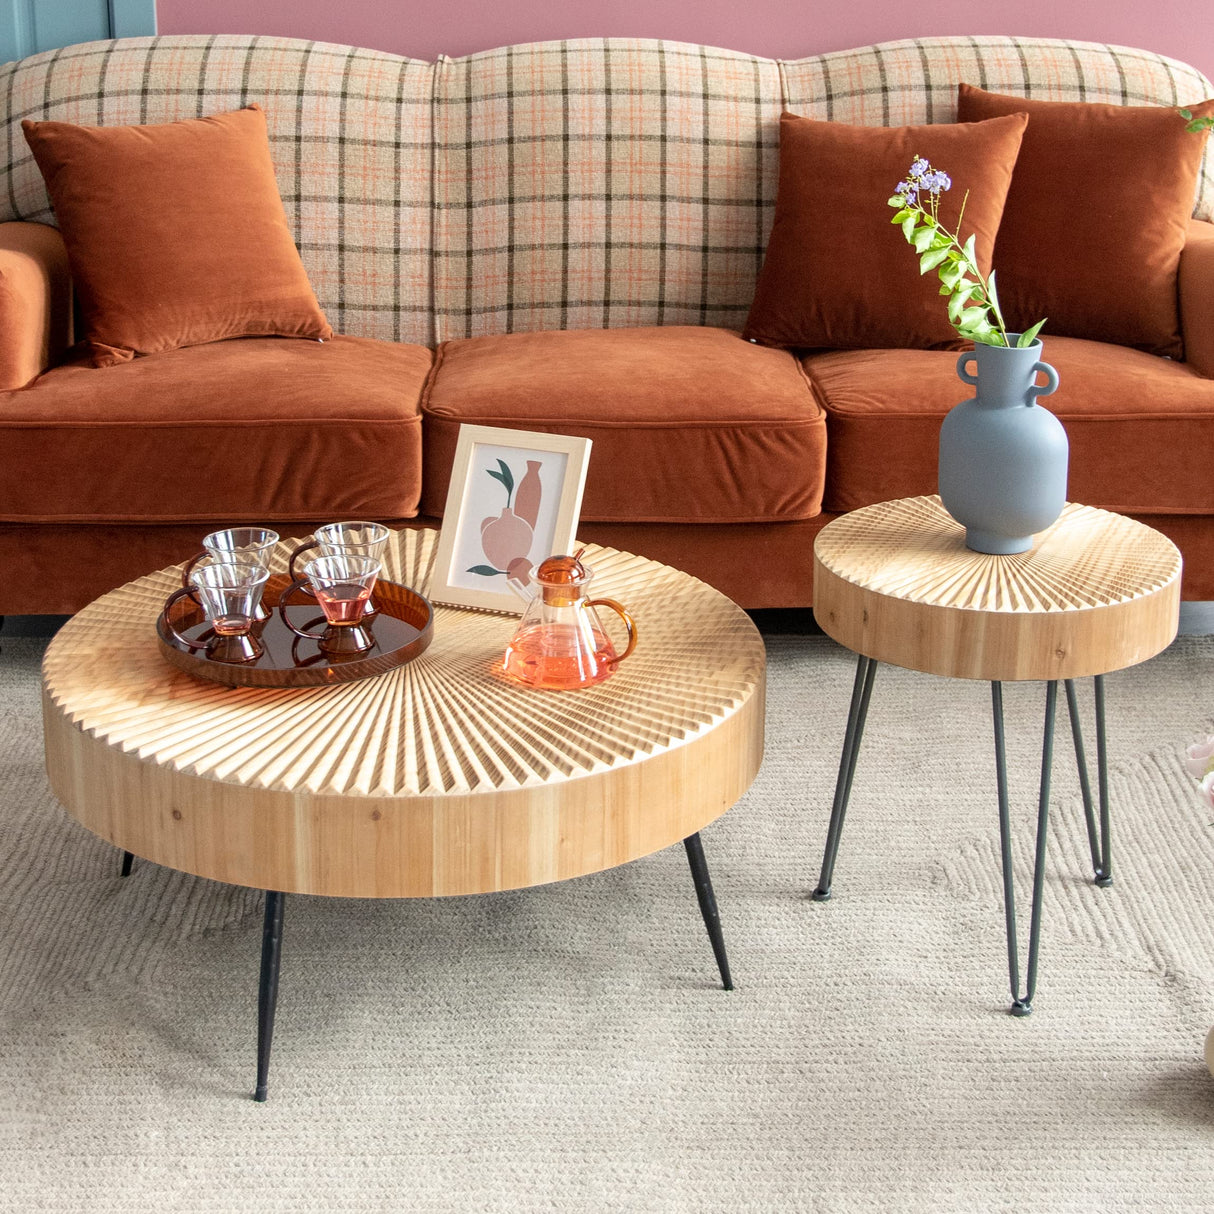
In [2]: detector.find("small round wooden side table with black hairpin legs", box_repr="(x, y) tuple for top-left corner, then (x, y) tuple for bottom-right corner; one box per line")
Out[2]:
(813, 497), (1180, 1016)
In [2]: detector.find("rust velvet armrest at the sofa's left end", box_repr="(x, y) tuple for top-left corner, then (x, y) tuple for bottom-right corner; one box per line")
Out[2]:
(0, 223), (72, 388)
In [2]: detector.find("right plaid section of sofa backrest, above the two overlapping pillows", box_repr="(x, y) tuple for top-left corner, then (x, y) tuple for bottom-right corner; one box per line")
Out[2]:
(781, 38), (1214, 219)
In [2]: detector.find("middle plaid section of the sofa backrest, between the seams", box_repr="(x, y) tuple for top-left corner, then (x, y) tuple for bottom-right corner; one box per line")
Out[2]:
(435, 39), (779, 339)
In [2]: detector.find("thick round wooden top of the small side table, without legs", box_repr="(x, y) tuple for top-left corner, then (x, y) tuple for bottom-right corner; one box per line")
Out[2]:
(813, 497), (1181, 680)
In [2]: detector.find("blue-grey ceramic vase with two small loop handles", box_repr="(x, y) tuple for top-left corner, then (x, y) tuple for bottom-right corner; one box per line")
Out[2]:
(938, 334), (1068, 555)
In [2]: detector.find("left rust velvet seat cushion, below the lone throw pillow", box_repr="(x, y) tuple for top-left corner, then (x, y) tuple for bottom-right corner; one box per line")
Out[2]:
(0, 337), (431, 523)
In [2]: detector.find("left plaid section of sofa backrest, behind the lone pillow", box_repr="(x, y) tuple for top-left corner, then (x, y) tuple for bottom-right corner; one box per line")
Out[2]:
(0, 36), (435, 345)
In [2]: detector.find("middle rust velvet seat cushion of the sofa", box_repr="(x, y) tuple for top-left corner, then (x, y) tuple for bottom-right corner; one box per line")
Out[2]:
(422, 325), (826, 523)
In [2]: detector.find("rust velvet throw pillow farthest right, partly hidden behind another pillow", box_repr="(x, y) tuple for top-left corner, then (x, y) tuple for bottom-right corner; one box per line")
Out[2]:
(958, 84), (1214, 358)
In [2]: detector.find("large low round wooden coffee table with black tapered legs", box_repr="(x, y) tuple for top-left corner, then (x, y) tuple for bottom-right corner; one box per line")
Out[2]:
(42, 531), (765, 1100)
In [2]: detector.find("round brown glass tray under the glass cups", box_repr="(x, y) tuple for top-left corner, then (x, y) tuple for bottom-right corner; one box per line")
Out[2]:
(155, 574), (435, 687)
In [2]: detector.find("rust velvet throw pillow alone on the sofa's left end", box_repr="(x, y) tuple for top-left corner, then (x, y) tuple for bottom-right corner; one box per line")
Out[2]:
(22, 106), (333, 367)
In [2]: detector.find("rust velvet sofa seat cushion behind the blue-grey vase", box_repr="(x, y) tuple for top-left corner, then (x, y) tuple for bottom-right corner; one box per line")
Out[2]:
(805, 336), (1214, 515)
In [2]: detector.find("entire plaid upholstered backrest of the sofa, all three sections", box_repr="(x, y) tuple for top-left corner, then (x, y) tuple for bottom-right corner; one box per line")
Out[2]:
(0, 35), (1214, 345)
